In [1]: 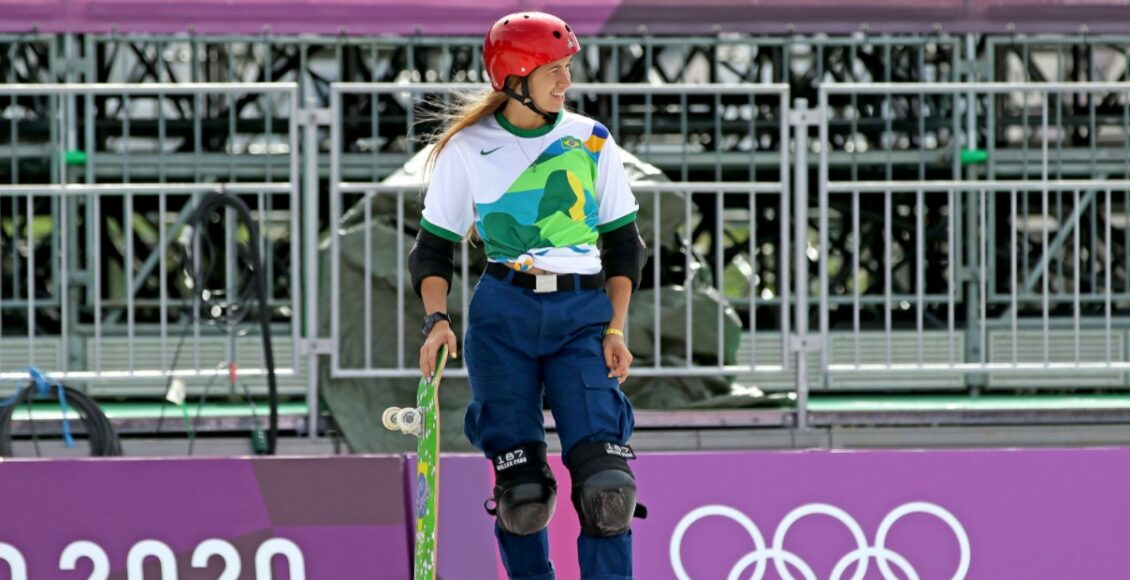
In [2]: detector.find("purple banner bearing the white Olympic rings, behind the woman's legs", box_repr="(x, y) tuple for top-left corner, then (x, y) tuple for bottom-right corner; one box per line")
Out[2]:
(440, 449), (1130, 580)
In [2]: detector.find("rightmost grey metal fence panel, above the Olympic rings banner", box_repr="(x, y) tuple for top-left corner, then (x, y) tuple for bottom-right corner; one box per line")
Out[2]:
(817, 83), (1130, 388)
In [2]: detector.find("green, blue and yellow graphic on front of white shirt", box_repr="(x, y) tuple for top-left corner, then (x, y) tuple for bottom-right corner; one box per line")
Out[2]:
(475, 123), (608, 261)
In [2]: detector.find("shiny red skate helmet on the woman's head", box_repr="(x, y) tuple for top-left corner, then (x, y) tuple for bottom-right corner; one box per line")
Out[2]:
(483, 12), (581, 90)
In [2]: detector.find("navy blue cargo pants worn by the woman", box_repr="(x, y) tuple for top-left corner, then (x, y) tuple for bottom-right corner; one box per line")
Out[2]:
(463, 272), (634, 580)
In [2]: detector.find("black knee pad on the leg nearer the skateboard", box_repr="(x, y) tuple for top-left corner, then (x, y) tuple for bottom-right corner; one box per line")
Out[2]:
(485, 443), (557, 536)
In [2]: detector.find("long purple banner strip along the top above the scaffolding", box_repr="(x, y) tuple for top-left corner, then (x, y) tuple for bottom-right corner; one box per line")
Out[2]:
(0, 0), (1130, 36)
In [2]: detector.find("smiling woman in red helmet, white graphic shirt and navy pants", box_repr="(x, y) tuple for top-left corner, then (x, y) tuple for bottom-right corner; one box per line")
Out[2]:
(409, 12), (646, 580)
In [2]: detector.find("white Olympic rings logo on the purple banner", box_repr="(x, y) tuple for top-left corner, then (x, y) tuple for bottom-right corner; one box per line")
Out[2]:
(670, 502), (970, 580)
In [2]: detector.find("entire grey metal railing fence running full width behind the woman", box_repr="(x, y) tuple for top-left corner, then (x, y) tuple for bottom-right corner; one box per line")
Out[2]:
(0, 76), (1130, 424)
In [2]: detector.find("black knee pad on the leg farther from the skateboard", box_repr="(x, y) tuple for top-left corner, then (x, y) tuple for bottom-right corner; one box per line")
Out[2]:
(565, 441), (647, 537)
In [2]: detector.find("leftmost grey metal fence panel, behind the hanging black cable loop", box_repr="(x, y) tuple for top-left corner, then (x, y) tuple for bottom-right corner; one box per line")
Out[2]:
(0, 84), (302, 395)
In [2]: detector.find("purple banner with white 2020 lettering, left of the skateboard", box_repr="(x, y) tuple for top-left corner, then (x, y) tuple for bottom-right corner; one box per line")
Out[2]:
(0, 457), (411, 580)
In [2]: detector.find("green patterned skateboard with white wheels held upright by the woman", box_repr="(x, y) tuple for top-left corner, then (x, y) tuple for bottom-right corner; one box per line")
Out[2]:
(381, 346), (447, 580)
